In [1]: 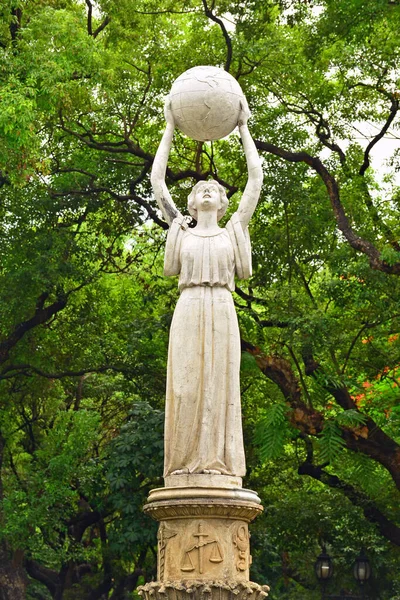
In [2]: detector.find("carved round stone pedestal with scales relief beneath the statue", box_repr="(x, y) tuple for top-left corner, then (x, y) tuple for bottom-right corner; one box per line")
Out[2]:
(140, 475), (268, 600)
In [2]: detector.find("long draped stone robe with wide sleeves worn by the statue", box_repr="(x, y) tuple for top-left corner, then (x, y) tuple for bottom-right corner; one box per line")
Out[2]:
(164, 213), (251, 477)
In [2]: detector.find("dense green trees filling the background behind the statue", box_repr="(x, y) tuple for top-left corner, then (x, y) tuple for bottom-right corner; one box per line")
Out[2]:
(0, 0), (400, 600)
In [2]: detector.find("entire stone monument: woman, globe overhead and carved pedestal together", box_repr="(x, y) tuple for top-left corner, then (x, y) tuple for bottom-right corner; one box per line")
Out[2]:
(139, 67), (269, 600)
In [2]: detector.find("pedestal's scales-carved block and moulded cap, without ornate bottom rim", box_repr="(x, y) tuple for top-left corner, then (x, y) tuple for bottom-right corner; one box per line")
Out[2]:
(144, 487), (262, 582)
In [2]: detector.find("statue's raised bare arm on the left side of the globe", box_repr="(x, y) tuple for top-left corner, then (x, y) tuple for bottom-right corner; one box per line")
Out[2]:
(150, 98), (180, 225)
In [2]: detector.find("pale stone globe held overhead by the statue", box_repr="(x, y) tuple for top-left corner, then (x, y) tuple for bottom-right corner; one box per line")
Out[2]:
(169, 66), (244, 142)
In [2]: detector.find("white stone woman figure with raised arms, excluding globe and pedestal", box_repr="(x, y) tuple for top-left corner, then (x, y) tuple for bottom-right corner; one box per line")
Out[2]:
(151, 100), (262, 477)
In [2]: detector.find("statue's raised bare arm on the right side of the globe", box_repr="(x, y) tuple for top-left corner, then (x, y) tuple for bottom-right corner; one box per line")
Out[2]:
(237, 98), (263, 229)
